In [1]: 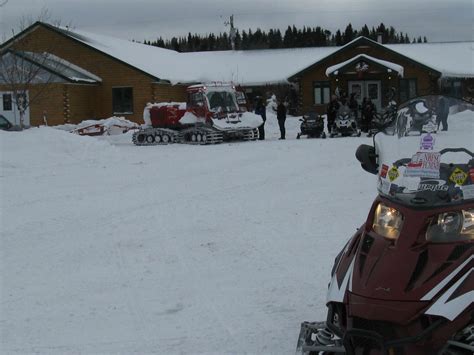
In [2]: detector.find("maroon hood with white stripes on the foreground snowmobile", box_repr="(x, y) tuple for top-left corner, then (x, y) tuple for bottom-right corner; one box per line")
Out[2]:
(328, 197), (474, 323)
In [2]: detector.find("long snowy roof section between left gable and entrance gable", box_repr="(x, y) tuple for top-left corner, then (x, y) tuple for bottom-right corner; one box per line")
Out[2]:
(55, 24), (338, 85)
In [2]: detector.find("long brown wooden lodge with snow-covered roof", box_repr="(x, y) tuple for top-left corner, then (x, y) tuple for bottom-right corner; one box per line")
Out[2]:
(0, 22), (474, 126)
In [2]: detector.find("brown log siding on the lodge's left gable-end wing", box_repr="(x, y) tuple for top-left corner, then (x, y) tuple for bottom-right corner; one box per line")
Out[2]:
(10, 26), (185, 124)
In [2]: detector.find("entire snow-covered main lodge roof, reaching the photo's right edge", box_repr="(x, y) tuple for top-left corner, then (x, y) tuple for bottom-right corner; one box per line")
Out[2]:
(12, 24), (474, 86)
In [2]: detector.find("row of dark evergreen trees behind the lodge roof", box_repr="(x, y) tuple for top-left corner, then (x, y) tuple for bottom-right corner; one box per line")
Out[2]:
(143, 23), (428, 52)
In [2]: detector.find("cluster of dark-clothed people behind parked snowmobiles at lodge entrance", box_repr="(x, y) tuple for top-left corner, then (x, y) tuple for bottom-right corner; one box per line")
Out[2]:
(326, 93), (377, 133)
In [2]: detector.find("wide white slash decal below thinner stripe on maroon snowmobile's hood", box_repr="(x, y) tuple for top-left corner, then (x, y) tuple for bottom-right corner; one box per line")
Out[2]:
(425, 268), (474, 321)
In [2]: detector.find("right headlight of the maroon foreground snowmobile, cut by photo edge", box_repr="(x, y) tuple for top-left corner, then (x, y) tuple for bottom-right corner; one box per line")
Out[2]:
(426, 209), (474, 243)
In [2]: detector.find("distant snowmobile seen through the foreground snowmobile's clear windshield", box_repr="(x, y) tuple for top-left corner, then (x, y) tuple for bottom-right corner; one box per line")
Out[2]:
(399, 99), (438, 135)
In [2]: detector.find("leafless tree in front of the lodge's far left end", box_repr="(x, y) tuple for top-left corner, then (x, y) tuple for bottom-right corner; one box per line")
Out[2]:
(0, 8), (67, 129)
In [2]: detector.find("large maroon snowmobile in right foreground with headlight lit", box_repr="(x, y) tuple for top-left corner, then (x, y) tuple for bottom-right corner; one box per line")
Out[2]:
(297, 96), (474, 355)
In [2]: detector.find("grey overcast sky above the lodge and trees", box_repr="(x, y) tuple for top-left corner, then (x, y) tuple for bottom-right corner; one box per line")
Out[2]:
(0, 0), (474, 42)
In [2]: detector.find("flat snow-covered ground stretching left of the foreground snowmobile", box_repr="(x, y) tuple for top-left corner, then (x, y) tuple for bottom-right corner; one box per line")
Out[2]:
(0, 116), (376, 354)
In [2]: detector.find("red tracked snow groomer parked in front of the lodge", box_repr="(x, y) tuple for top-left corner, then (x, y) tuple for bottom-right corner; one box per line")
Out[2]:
(132, 84), (263, 145)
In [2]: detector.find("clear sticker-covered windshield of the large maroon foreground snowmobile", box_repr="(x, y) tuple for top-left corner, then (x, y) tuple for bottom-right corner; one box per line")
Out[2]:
(374, 96), (474, 207)
